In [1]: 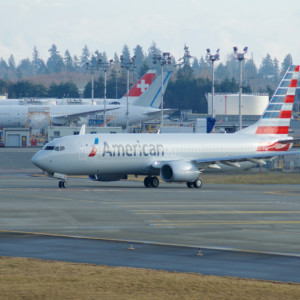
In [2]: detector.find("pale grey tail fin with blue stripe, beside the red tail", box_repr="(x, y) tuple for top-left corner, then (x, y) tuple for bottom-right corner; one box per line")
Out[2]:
(132, 71), (172, 108)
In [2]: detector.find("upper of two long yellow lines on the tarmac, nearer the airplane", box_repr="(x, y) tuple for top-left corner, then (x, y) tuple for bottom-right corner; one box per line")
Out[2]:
(132, 210), (300, 215)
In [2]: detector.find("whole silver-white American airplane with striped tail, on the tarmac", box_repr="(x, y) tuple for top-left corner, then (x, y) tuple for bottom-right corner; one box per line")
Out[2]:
(32, 66), (300, 188)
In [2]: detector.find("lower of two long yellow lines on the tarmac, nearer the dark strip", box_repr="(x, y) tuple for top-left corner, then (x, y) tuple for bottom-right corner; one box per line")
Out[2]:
(149, 220), (300, 227)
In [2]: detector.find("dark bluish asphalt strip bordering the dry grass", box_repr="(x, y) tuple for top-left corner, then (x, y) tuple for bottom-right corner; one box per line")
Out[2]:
(0, 232), (300, 282)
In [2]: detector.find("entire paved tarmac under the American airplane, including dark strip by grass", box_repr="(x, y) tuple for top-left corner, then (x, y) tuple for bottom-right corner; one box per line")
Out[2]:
(0, 149), (300, 283)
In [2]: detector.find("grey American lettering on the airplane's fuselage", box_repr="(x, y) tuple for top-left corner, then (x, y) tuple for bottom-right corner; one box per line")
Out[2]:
(102, 141), (165, 157)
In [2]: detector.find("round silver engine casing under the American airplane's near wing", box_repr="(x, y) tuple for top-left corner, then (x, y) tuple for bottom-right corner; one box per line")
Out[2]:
(160, 161), (199, 182)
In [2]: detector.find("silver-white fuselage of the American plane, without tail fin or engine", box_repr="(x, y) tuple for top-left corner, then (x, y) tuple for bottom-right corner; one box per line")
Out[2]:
(33, 134), (284, 175)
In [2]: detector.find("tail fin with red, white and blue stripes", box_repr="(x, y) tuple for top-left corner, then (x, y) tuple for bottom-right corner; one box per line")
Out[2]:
(237, 66), (300, 138)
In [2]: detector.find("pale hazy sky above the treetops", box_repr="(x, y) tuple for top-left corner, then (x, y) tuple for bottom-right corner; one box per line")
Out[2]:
(0, 0), (300, 64)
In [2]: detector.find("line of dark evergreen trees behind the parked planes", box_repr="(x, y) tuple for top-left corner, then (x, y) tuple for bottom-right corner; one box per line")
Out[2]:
(0, 42), (292, 113)
